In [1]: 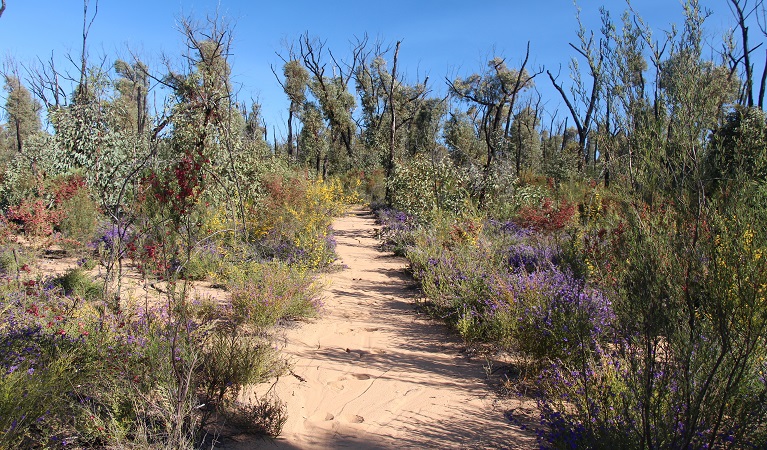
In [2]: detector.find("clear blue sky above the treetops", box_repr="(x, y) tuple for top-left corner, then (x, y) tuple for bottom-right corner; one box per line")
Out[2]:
(0, 0), (744, 137)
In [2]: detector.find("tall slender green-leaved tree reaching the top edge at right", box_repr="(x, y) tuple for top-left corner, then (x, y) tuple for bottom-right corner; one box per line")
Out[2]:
(642, 1), (739, 196)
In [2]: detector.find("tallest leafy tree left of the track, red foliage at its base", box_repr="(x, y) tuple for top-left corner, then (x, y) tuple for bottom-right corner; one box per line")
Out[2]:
(157, 15), (265, 243)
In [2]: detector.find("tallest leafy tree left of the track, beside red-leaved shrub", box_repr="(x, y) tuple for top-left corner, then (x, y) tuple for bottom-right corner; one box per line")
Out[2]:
(155, 16), (247, 229)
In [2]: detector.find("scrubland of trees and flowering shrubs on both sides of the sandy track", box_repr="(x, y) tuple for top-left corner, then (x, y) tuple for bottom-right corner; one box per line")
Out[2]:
(0, 0), (767, 449)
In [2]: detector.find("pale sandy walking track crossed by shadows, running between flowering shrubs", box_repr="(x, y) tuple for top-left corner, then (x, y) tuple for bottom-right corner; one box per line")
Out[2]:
(236, 209), (534, 449)
